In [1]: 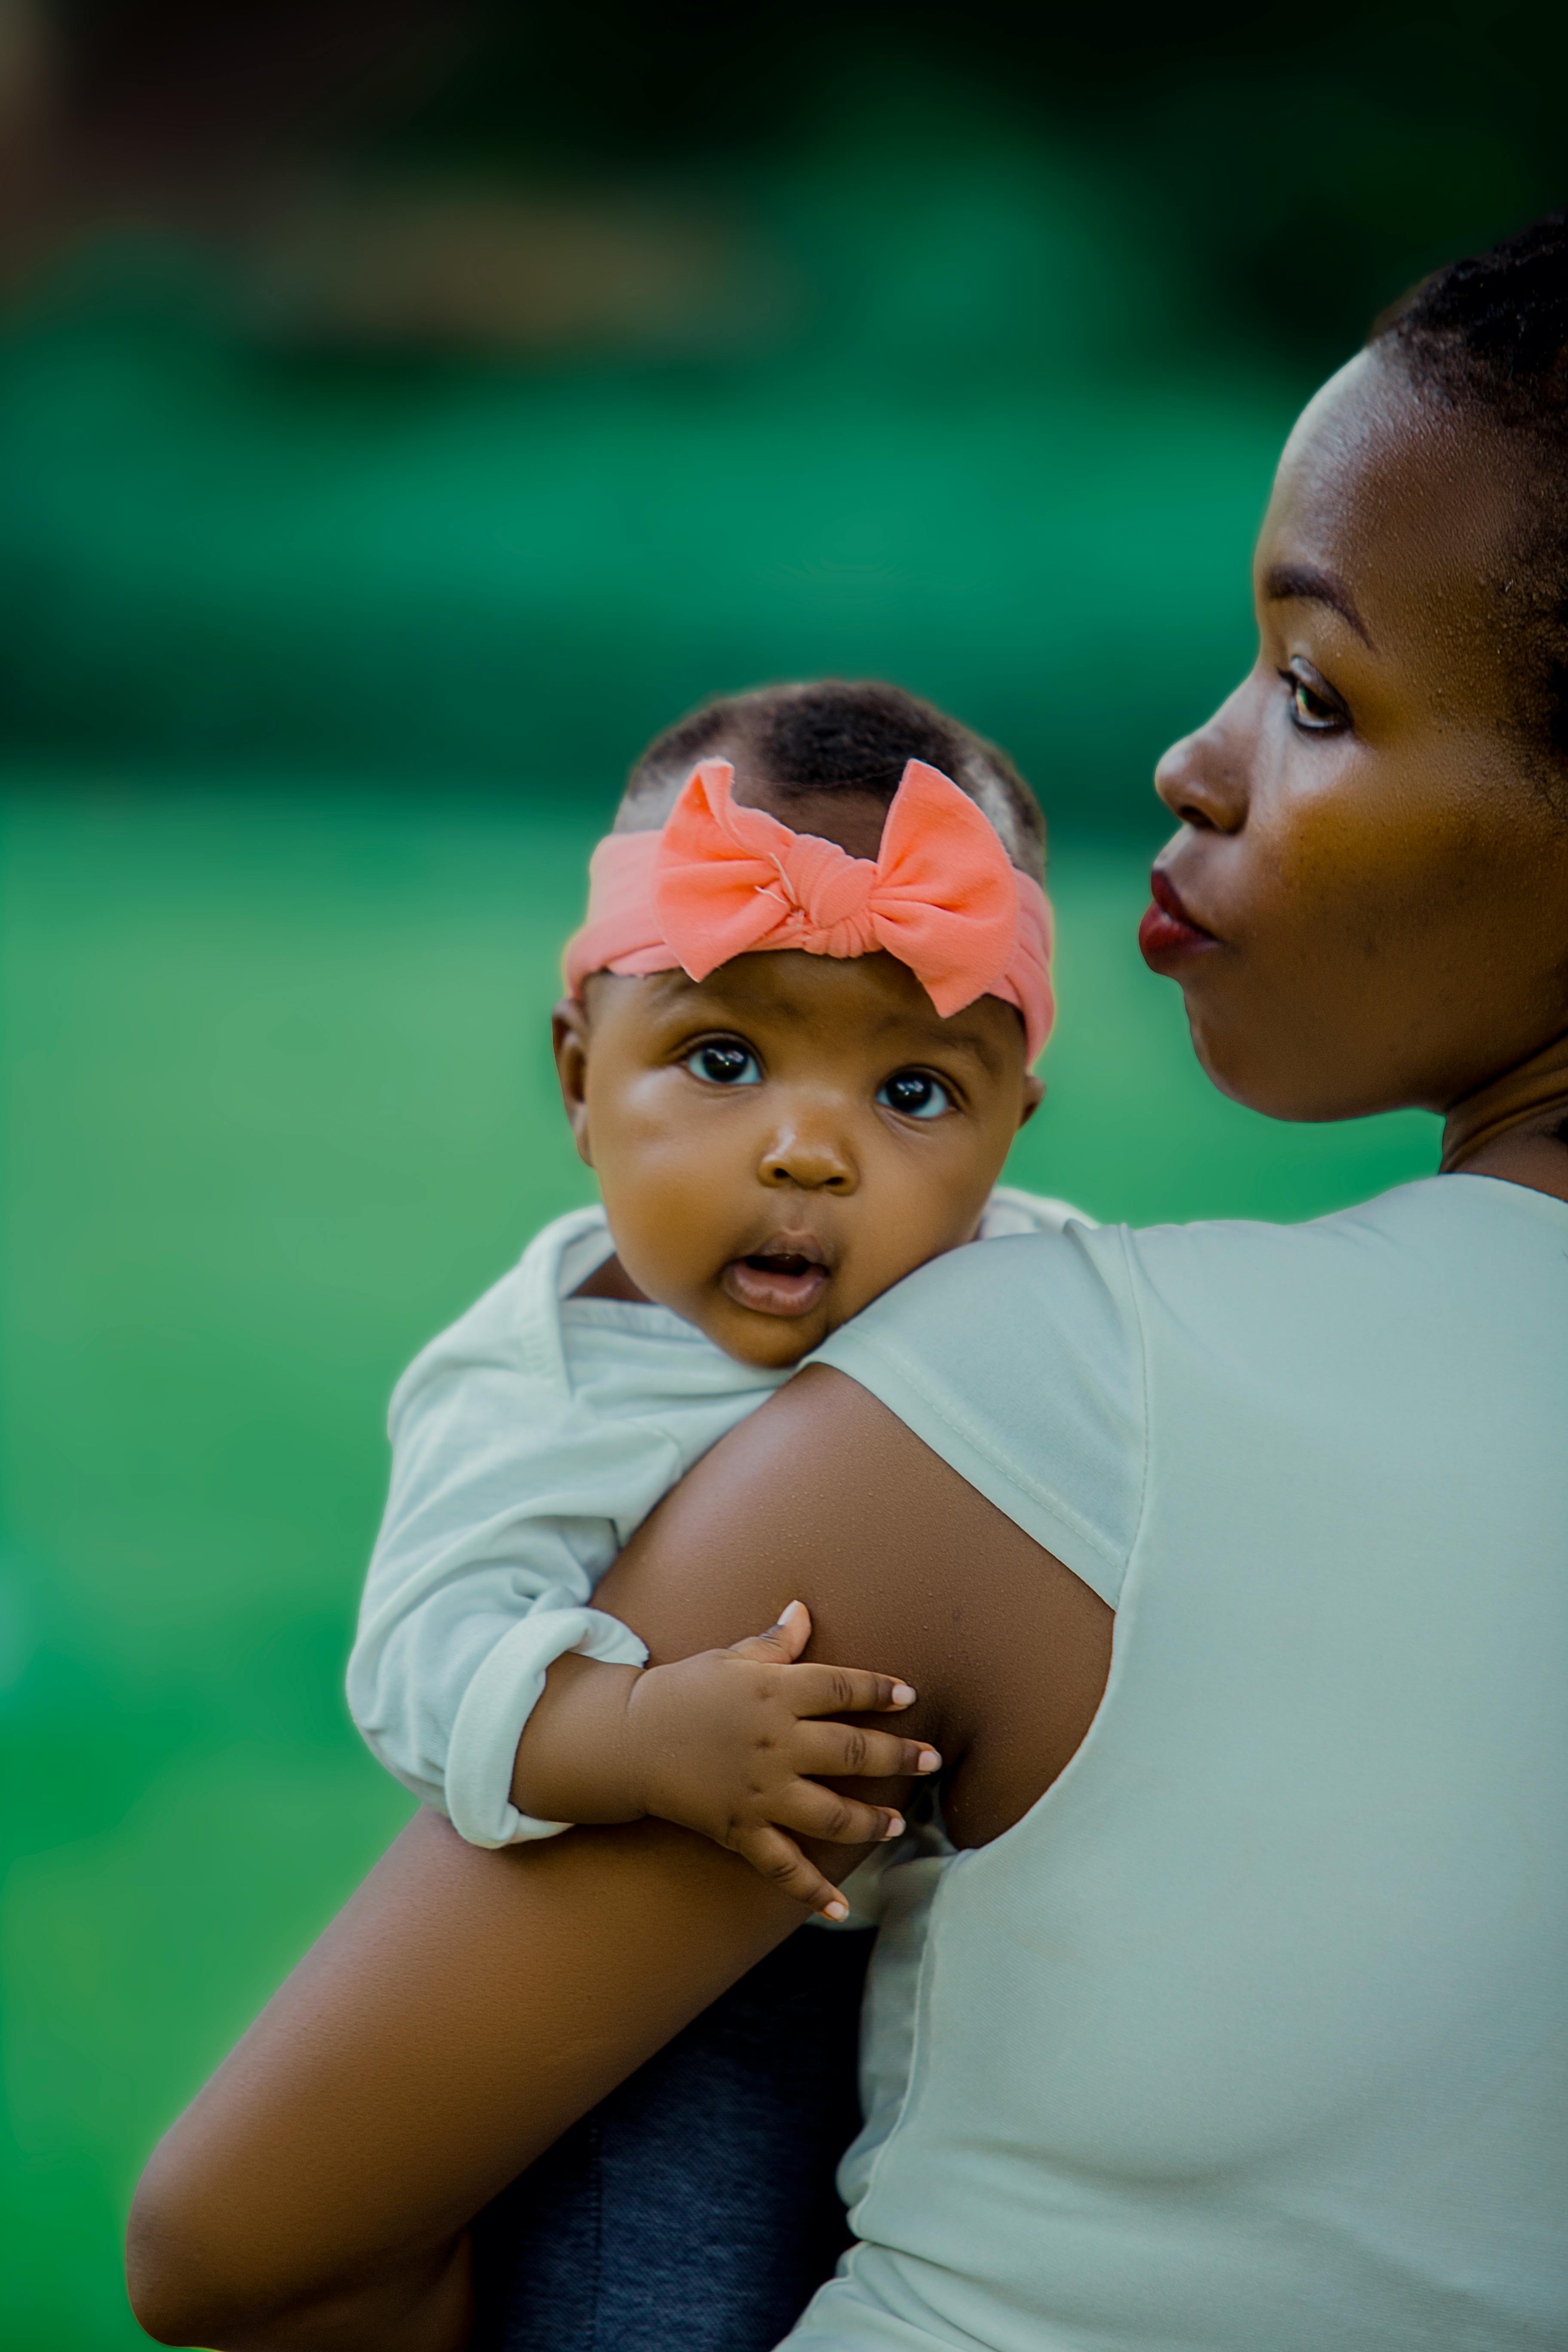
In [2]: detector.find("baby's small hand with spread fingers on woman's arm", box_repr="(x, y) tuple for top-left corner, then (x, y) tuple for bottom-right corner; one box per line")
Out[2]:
(625, 1602), (943, 1919)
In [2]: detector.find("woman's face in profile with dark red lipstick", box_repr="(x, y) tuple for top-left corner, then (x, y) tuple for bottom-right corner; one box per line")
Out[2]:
(1140, 353), (1568, 1120)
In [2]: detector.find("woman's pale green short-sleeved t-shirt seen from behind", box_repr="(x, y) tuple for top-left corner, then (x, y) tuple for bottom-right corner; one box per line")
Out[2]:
(790, 1176), (1568, 2352)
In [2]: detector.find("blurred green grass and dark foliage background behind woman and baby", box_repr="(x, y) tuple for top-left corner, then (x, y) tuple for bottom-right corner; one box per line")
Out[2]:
(0, 0), (1568, 2352)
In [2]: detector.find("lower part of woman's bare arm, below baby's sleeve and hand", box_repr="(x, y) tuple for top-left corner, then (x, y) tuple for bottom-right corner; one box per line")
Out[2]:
(129, 1811), (799, 2352)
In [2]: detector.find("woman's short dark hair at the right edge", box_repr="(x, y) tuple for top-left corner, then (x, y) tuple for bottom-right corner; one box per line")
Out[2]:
(1368, 211), (1568, 812)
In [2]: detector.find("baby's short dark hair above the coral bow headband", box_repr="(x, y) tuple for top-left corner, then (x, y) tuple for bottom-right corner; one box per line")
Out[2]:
(616, 677), (1046, 882)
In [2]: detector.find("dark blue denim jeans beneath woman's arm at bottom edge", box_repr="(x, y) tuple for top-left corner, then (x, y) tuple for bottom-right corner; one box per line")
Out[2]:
(470, 1929), (872, 2352)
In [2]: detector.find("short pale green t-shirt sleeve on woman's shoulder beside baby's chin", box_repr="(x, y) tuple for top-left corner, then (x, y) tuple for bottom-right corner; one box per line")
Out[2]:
(813, 1225), (1147, 1609)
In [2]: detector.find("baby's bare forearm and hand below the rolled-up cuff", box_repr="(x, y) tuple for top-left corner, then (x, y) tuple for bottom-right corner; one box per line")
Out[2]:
(512, 1602), (943, 1919)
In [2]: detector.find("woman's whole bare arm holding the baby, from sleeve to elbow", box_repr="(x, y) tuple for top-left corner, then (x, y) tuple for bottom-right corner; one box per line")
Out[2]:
(129, 1371), (1109, 2352)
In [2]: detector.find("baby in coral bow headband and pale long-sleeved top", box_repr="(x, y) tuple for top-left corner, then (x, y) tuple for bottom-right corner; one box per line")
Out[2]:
(348, 682), (1077, 1919)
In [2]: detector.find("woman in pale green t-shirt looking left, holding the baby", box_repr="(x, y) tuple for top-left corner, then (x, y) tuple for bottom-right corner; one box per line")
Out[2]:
(132, 219), (1568, 2352)
